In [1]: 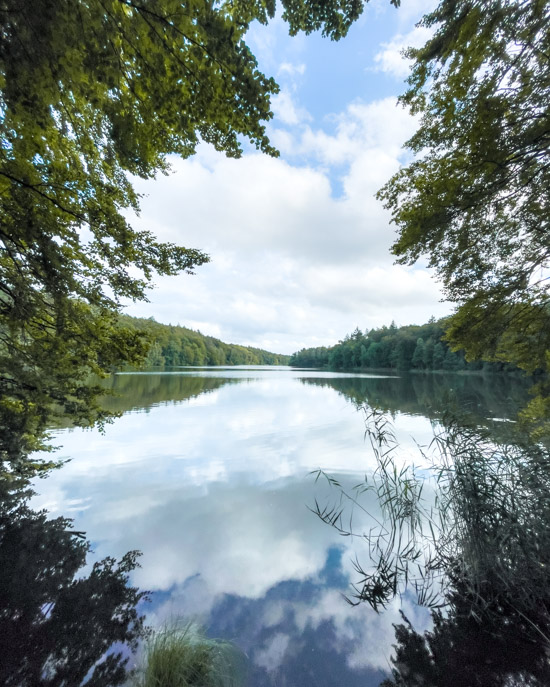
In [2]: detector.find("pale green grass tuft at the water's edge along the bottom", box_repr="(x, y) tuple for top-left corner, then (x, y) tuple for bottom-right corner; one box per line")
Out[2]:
(134, 622), (246, 687)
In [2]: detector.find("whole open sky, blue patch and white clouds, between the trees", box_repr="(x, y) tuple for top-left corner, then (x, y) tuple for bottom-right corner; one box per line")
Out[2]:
(126, 0), (452, 353)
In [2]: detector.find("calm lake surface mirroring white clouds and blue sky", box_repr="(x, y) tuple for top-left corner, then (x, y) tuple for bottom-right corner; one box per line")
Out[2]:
(32, 367), (523, 687)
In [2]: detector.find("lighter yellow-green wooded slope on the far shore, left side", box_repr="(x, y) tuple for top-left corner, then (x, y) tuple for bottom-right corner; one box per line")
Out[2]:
(121, 315), (289, 367)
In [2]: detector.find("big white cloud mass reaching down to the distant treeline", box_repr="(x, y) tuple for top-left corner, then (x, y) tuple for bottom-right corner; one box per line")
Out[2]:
(128, 90), (449, 353)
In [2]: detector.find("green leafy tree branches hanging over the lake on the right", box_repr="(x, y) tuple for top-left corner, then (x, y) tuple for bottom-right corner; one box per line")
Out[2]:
(379, 0), (550, 392)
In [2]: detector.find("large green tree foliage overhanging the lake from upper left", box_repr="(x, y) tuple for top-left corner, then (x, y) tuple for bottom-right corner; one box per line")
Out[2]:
(0, 0), (390, 467)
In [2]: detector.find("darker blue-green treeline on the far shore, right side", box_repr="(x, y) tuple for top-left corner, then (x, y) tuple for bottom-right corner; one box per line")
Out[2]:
(289, 318), (517, 372)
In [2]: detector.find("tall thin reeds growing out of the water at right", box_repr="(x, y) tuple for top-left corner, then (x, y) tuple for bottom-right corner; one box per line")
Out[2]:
(312, 409), (550, 647)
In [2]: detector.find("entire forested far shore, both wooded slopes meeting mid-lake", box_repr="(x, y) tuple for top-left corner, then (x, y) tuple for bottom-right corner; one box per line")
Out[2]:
(120, 315), (536, 377)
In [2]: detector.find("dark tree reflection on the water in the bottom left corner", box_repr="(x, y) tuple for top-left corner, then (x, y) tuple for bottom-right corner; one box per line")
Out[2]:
(0, 484), (146, 687)
